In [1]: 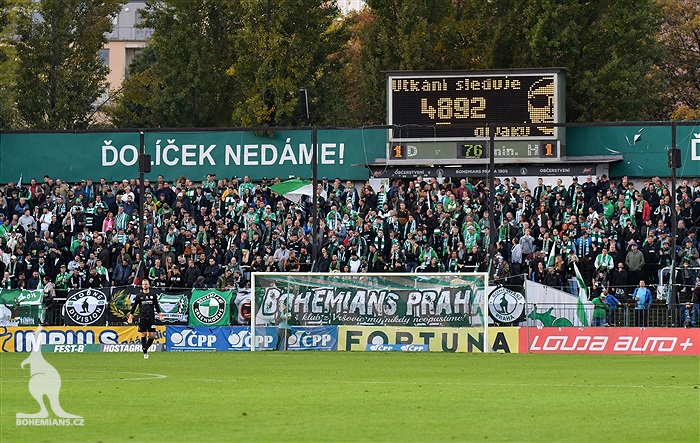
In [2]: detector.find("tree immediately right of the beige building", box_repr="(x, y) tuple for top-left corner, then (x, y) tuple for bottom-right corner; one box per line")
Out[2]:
(108, 0), (240, 127)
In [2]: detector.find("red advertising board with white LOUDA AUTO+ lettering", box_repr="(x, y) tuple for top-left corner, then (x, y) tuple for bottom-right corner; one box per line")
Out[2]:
(520, 328), (700, 355)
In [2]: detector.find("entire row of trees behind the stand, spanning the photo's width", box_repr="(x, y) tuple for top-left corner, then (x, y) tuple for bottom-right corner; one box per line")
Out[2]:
(0, 0), (688, 129)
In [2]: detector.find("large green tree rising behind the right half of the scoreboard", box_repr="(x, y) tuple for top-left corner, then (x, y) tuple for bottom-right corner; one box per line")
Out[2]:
(482, 0), (661, 121)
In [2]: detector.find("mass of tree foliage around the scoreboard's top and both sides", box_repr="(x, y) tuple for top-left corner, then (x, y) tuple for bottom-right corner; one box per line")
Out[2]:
(357, 0), (661, 123)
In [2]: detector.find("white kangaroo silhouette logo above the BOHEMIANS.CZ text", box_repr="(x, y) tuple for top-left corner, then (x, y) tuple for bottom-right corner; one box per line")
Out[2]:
(16, 328), (83, 419)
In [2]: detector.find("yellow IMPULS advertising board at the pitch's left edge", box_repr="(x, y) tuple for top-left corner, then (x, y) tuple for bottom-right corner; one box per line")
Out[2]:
(0, 326), (165, 352)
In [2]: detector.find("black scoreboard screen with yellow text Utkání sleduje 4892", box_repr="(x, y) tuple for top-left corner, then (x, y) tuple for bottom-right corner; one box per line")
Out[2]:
(387, 71), (561, 140)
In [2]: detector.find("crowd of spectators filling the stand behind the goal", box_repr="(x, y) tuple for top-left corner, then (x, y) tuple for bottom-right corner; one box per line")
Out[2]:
(0, 174), (700, 306)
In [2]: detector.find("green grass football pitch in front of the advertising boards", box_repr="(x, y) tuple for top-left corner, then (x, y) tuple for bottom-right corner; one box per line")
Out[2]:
(0, 352), (700, 442)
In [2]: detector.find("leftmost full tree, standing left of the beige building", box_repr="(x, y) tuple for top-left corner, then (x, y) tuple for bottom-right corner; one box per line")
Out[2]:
(15, 0), (124, 129)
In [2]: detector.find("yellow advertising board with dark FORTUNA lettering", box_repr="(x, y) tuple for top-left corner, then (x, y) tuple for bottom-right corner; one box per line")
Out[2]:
(338, 326), (519, 353)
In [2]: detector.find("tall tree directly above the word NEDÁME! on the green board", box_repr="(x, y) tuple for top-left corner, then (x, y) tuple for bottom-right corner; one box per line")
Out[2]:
(229, 0), (347, 126)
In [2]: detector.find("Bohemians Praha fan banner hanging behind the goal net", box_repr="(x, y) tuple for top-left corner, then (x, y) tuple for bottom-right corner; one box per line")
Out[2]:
(255, 284), (483, 326)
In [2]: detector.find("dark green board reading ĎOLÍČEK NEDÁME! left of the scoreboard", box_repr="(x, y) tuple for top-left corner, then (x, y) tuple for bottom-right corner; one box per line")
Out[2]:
(0, 129), (386, 183)
